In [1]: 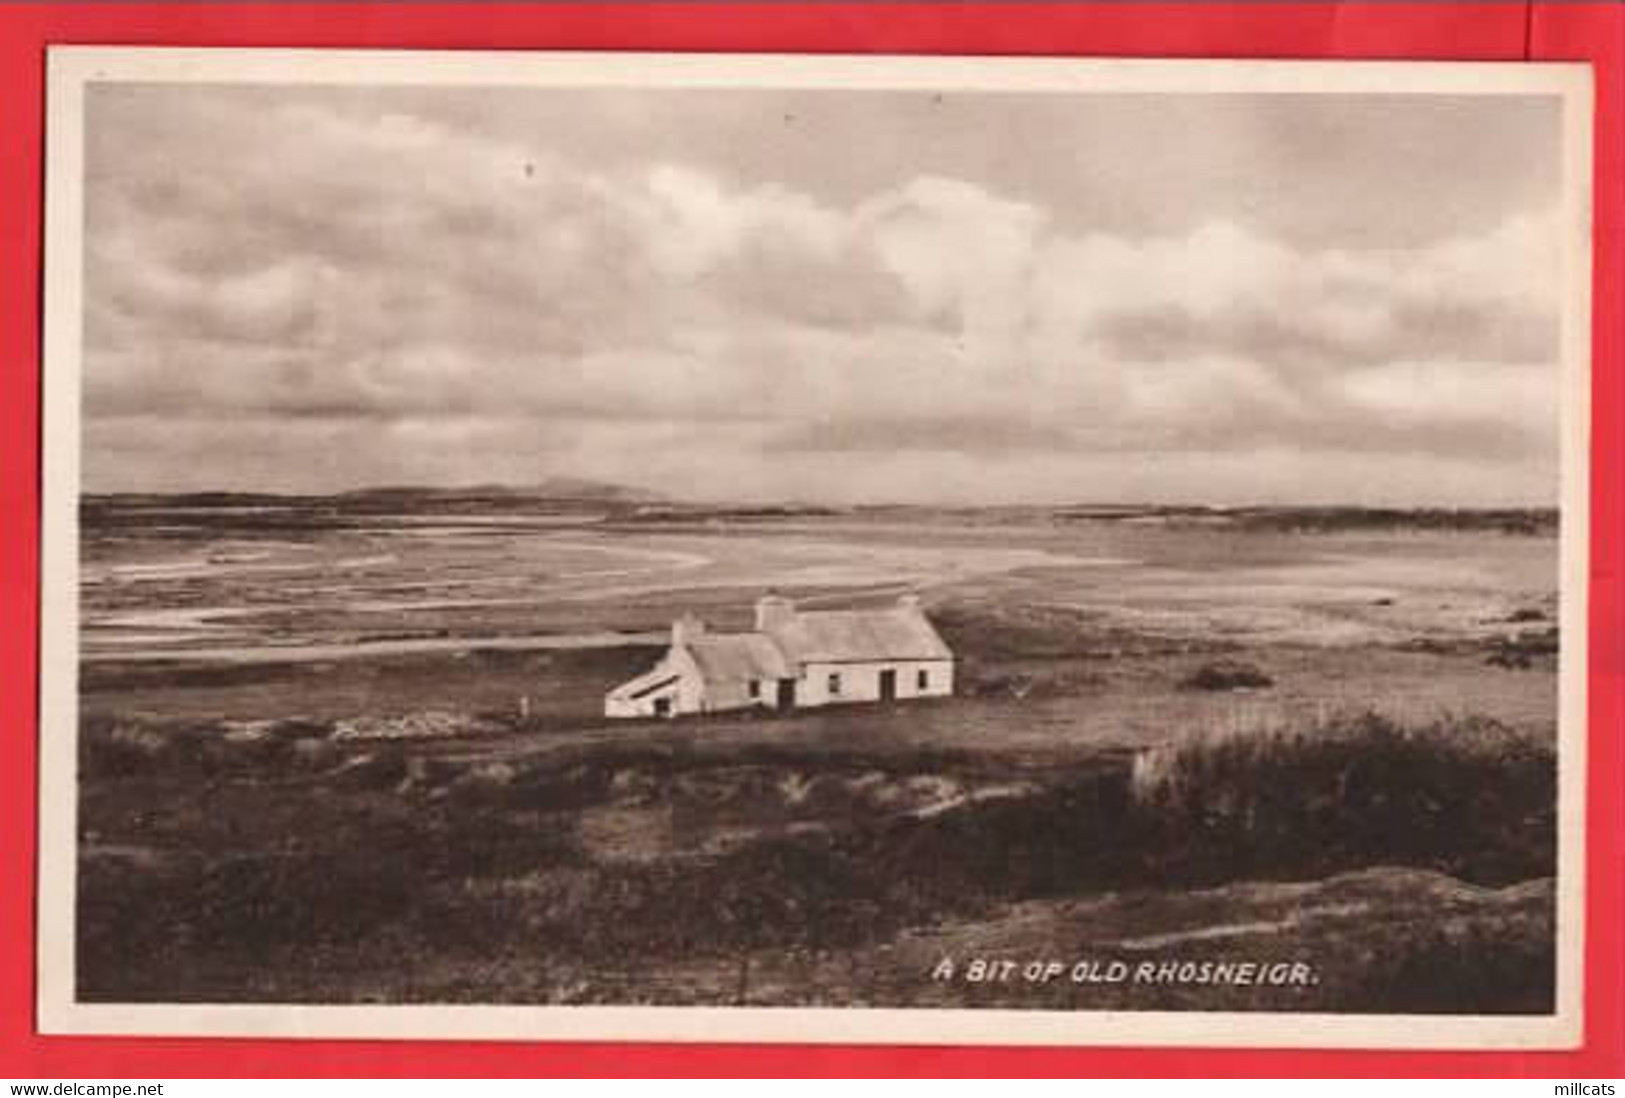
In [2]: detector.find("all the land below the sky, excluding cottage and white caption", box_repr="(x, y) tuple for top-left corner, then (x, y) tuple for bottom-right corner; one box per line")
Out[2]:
(76, 482), (1558, 1014)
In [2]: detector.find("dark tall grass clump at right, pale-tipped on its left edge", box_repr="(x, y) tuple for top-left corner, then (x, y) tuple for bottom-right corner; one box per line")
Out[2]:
(1129, 713), (1557, 884)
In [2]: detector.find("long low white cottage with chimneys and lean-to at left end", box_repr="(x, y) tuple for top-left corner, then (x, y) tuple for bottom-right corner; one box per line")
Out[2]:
(605, 594), (954, 716)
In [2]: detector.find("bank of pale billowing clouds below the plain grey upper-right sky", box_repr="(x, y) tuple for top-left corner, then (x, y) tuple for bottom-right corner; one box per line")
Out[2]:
(85, 88), (1560, 500)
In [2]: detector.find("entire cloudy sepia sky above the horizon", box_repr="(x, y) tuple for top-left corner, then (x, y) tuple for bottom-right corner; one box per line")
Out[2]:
(85, 84), (1560, 504)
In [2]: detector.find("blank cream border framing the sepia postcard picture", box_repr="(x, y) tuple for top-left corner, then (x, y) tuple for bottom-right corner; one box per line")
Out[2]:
(36, 45), (1593, 1049)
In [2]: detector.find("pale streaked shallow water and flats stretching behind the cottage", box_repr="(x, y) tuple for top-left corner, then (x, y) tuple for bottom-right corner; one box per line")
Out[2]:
(81, 513), (1557, 661)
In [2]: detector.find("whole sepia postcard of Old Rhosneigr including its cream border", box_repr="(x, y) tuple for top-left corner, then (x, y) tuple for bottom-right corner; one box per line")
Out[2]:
(39, 47), (1591, 1048)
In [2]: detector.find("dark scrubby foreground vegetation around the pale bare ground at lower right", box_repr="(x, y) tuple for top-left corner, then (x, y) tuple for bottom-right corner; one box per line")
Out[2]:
(78, 704), (1555, 1012)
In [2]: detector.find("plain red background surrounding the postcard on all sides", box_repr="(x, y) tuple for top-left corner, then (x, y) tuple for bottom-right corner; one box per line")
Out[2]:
(0, 0), (1625, 1080)
